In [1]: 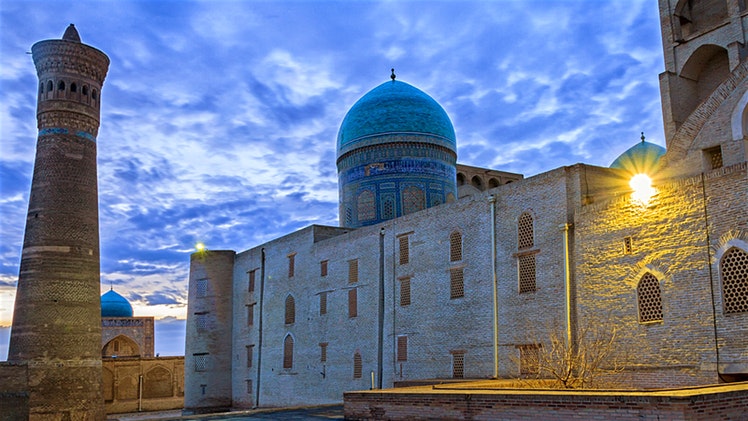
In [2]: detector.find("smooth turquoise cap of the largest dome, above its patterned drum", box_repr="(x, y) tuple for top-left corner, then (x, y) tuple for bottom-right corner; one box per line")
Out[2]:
(337, 80), (457, 157)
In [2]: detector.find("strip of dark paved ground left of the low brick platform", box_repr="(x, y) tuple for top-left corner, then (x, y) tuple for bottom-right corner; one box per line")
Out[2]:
(107, 405), (343, 421)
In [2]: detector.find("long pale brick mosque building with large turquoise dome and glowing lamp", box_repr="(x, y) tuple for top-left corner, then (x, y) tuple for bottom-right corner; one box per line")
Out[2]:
(185, 0), (748, 413)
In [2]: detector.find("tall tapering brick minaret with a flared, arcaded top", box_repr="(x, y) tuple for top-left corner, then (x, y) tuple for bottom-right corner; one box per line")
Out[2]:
(8, 24), (109, 420)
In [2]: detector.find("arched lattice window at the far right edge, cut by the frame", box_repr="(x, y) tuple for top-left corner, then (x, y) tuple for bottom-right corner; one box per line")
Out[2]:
(719, 247), (748, 313)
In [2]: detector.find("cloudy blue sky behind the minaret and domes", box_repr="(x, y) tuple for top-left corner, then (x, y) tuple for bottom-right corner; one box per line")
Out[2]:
(0, 0), (665, 360)
